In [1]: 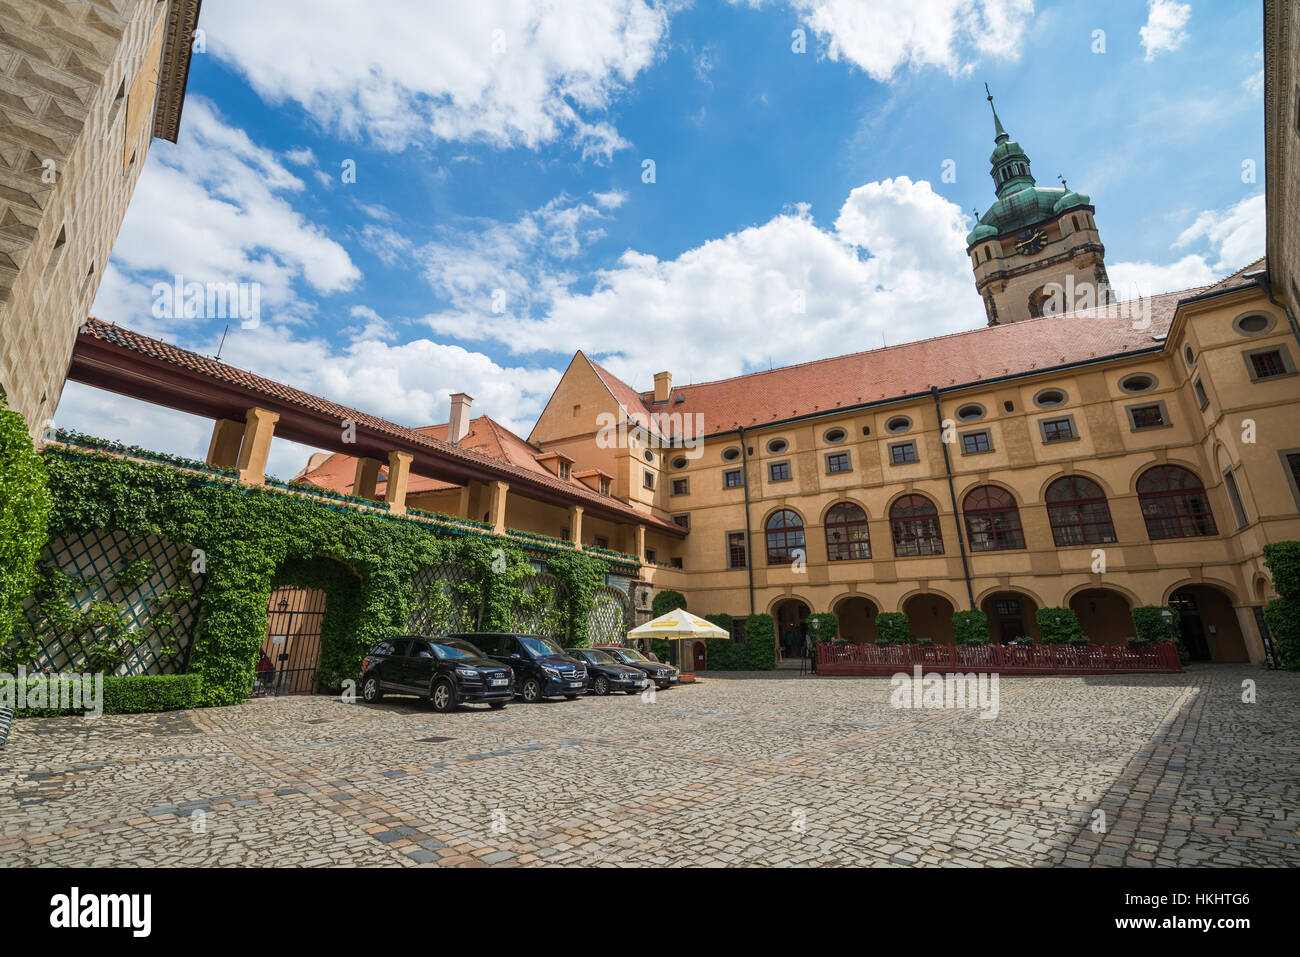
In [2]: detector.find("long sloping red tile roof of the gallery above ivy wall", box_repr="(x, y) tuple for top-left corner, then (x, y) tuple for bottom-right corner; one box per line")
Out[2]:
(74, 317), (681, 537)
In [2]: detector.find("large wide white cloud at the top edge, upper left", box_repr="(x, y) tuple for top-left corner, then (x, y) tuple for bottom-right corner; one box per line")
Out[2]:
(203, 0), (668, 160)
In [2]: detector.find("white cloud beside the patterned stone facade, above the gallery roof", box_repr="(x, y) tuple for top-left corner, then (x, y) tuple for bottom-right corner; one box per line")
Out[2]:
(95, 98), (361, 324)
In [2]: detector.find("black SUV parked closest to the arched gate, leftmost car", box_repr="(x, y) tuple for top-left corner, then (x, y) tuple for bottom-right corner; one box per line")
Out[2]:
(356, 636), (515, 711)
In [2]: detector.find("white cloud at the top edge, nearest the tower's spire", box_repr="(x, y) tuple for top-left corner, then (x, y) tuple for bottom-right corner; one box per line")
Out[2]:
(732, 0), (1034, 82)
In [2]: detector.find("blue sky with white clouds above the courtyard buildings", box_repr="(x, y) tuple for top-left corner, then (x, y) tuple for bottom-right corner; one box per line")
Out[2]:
(56, 0), (1264, 479)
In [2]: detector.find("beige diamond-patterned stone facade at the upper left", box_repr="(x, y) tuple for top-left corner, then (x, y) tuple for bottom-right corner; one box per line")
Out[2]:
(0, 0), (199, 434)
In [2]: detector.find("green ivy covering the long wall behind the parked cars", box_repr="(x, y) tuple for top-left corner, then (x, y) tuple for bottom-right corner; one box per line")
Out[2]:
(3, 447), (610, 705)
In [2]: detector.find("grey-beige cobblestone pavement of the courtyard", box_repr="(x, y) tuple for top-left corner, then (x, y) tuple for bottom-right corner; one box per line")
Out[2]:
(0, 666), (1300, 866)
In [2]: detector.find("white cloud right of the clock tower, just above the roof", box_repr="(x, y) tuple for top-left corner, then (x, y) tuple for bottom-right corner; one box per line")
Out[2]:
(1106, 192), (1265, 299)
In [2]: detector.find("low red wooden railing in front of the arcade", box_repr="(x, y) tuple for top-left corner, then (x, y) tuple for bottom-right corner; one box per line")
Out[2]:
(816, 641), (1183, 675)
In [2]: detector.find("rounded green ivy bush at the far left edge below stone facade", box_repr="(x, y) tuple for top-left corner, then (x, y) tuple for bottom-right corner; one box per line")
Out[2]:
(0, 395), (49, 646)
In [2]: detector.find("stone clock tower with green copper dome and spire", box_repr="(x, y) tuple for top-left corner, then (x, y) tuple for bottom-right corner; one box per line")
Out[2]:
(966, 86), (1114, 325)
